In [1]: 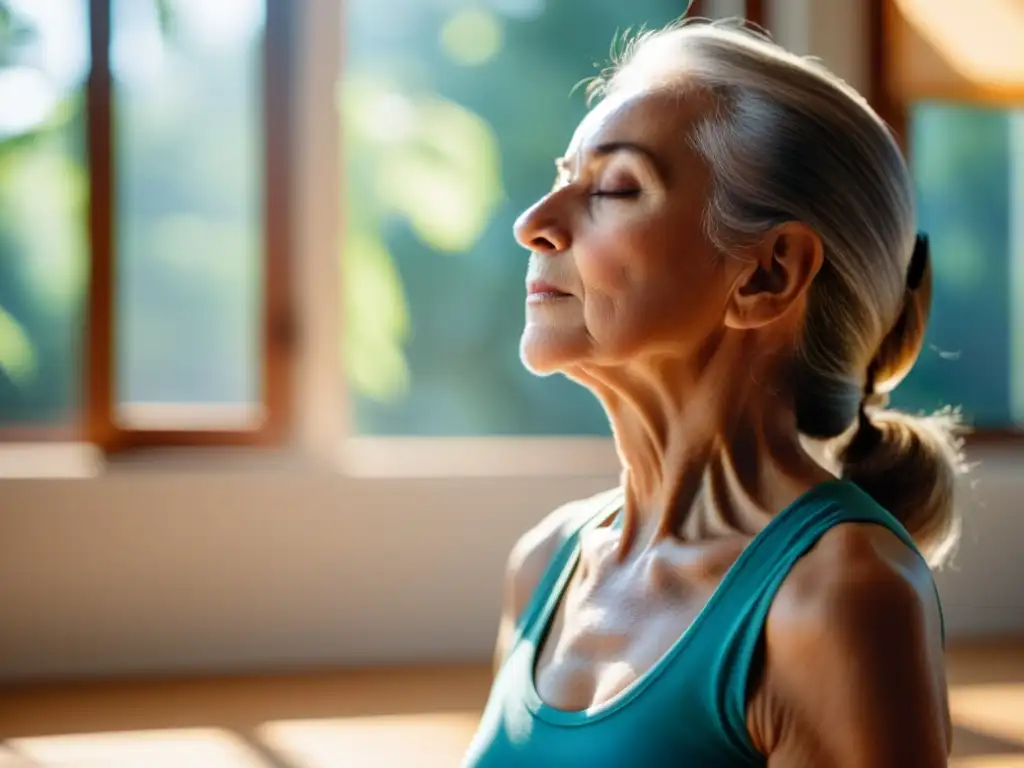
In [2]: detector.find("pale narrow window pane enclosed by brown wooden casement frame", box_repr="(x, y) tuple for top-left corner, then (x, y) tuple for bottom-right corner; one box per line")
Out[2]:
(112, 0), (264, 428)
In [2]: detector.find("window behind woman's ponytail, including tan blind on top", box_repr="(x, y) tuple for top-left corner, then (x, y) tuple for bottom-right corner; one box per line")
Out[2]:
(874, 0), (1024, 433)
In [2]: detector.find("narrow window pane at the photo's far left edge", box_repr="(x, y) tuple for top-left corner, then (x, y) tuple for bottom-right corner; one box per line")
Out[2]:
(0, 0), (88, 434)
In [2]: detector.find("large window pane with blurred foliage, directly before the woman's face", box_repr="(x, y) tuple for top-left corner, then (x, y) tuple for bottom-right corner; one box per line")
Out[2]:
(341, 0), (685, 435)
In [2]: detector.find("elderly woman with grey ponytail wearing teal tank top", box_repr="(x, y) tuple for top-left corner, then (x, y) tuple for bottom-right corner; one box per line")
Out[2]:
(464, 13), (962, 768)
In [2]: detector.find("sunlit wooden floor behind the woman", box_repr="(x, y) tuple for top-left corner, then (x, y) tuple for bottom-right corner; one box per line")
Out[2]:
(0, 643), (1024, 768)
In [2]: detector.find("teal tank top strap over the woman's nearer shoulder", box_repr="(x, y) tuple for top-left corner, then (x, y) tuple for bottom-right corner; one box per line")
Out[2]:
(700, 481), (945, 756)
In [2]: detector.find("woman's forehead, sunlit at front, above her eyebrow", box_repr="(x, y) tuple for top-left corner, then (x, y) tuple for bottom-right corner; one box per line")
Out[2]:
(568, 87), (709, 162)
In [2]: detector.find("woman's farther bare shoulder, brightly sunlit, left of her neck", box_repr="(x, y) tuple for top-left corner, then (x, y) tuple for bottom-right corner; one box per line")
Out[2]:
(495, 488), (620, 666)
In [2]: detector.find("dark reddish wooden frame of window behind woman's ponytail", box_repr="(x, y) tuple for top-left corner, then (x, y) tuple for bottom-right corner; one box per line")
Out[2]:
(867, 0), (1024, 445)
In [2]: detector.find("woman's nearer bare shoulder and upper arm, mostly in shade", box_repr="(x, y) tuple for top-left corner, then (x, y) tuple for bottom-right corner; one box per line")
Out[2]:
(752, 523), (951, 768)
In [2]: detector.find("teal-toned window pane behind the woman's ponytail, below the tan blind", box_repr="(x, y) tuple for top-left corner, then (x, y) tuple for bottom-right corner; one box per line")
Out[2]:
(893, 103), (1024, 434)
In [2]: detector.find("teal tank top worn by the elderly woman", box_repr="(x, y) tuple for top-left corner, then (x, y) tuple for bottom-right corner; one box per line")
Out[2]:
(462, 481), (937, 768)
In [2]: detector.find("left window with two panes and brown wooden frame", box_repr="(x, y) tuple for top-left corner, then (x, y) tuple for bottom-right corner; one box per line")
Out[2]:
(0, 0), (289, 449)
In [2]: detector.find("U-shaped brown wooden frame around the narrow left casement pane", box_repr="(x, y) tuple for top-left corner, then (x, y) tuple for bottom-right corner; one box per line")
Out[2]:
(82, 0), (296, 453)
